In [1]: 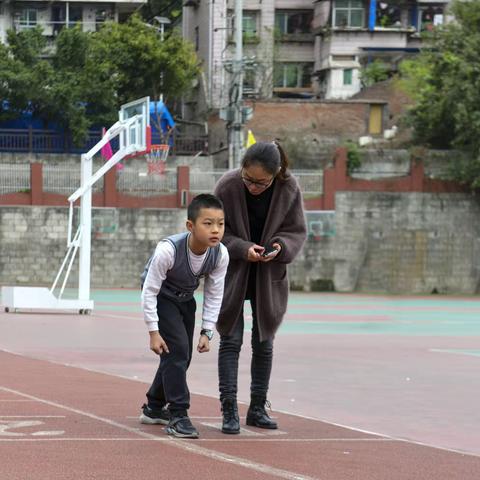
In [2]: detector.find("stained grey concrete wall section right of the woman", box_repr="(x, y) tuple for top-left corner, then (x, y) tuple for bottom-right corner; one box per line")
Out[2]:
(291, 192), (480, 294)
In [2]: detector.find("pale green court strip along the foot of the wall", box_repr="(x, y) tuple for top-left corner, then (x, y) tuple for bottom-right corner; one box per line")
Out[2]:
(74, 289), (480, 338)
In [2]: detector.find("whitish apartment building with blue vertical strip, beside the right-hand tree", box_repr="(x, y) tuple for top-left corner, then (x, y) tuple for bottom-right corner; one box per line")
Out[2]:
(312, 0), (450, 99)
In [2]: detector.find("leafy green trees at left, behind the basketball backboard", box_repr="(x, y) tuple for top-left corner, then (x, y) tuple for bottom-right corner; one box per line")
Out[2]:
(0, 16), (199, 145)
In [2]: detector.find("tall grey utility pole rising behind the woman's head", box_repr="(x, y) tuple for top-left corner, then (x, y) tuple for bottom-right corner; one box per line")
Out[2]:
(229, 0), (243, 168)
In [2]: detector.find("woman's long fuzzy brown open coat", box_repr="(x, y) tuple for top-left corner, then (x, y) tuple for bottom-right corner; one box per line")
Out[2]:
(215, 169), (306, 341)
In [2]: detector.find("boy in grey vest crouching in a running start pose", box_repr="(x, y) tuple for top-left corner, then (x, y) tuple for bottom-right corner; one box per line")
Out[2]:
(140, 194), (229, 438)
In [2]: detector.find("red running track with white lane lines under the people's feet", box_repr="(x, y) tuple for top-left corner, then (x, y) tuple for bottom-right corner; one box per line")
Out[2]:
(0, 351), (480, 480)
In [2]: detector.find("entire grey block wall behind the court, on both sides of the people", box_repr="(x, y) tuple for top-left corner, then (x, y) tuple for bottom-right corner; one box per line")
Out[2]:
(0, 192), (480, 294)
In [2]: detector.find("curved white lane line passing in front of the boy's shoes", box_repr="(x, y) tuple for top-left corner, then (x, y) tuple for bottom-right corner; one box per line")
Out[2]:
(0, 387), (315, 480)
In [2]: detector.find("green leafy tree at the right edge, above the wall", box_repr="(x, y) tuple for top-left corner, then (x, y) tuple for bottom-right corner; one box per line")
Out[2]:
(401, 0), (480, 189)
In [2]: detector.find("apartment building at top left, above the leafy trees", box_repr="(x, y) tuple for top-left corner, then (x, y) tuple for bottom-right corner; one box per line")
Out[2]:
(0, 0), (147, 42)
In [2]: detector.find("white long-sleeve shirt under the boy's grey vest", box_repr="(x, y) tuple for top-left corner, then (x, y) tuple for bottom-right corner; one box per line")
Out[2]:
(142, 241), (229, 332)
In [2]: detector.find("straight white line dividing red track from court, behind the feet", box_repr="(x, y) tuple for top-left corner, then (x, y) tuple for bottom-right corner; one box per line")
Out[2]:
(0, 349), (480, 458)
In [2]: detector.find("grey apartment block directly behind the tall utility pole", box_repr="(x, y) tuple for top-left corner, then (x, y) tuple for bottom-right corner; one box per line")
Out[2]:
(183, 0), (315, 111)
